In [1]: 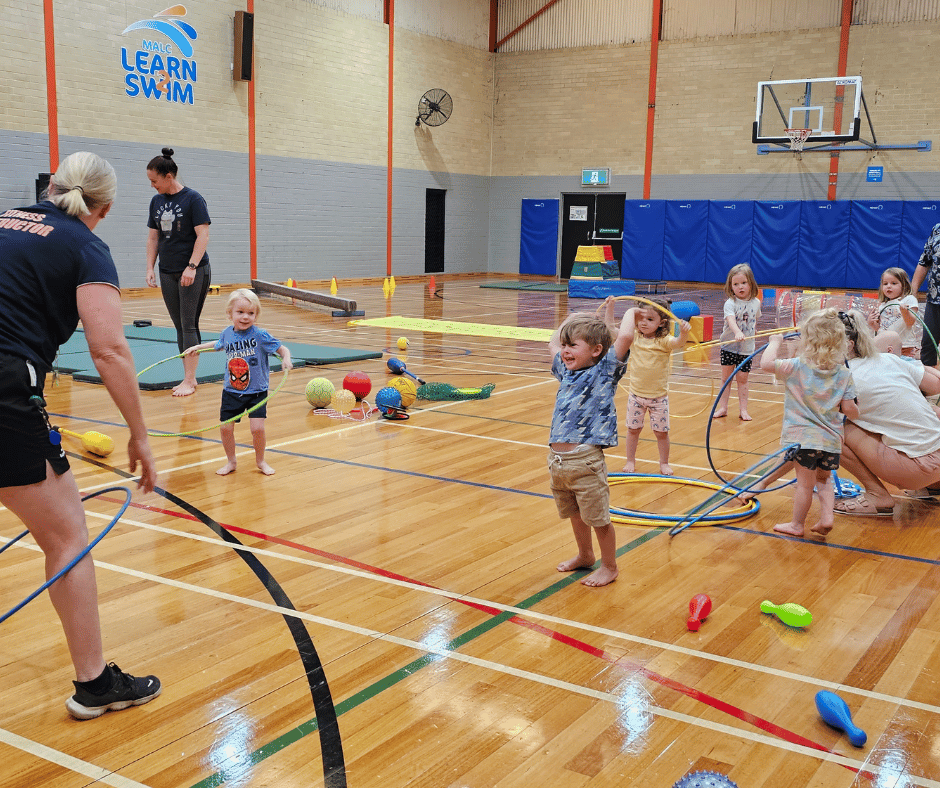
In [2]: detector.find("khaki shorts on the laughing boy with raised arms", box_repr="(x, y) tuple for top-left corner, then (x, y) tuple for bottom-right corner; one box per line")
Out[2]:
(548, 445), (610, 528)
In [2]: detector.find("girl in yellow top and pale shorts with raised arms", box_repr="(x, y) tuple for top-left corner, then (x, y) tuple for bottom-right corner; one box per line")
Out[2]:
(622, 299), (690, 476)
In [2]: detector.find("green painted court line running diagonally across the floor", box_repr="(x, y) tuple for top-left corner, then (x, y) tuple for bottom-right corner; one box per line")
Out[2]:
(191, 528), (666, 788)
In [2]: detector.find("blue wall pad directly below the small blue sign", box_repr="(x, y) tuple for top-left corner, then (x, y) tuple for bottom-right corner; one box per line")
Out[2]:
(845, 200), (904, 288)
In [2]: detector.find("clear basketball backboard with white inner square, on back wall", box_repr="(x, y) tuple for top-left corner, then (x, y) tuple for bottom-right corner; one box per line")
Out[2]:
(751, 77), (863, 145)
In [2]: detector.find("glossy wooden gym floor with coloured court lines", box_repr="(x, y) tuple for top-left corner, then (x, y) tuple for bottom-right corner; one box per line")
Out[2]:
(0, 277), (940, 788)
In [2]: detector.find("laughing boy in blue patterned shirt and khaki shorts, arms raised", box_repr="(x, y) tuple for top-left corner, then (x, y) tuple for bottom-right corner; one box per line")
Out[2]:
(548, 299), (630, 587)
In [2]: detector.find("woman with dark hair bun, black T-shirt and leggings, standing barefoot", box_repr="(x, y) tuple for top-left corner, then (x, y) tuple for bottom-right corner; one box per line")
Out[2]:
(147, 148), (211, 397)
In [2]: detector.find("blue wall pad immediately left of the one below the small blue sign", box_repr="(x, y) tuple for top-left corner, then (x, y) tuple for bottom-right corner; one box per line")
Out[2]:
(796, 200), (852, 287)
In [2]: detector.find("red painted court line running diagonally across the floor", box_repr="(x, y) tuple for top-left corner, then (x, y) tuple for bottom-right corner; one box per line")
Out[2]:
(110, 497), (860, 776)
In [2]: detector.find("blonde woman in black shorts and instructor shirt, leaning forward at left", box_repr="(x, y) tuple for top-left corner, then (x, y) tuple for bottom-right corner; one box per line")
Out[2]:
(0, 153), (160, 719)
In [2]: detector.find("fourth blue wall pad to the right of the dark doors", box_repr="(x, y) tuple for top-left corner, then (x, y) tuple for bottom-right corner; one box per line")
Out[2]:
(751, 201), (801, 286)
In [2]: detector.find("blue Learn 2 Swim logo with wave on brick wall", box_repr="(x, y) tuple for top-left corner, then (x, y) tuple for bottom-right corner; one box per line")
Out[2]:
(121, 5), (198, 104)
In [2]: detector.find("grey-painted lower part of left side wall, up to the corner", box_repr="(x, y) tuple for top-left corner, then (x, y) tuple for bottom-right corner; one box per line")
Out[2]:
(0, 131), (492, 287)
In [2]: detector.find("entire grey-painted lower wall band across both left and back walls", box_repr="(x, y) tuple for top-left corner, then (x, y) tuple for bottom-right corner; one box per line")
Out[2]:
(7, 131), (940, 287)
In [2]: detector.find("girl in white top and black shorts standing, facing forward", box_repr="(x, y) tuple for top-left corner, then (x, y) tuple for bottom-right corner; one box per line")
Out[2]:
(712, 263), (760, 421)
